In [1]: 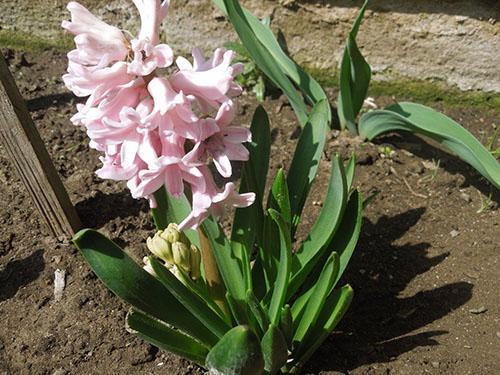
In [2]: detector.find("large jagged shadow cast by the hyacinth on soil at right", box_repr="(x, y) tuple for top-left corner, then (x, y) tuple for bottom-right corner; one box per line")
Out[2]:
(306, 208), (473, 373)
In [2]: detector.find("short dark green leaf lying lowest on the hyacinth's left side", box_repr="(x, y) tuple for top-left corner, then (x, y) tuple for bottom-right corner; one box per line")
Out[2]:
(127, 309), (208, 366)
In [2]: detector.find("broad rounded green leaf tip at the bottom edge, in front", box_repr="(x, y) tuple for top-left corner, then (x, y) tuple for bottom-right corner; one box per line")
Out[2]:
(206, 326), (264, 375)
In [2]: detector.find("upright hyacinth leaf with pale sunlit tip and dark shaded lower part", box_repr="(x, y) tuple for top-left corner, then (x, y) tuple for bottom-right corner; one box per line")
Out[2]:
(287, 101), (329, 228)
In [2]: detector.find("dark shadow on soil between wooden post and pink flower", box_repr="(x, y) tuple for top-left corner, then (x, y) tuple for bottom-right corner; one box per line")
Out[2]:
(76, 190), (149, 229)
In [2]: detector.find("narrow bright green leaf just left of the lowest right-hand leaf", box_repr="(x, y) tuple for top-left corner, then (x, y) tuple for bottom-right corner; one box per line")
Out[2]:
(293, 253), (339, 343)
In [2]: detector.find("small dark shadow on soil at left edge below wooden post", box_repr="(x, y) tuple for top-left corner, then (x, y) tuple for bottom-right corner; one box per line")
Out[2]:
(0, 250), (45, 302)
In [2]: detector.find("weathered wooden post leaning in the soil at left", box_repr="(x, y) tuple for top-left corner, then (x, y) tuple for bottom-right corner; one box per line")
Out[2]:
(0, 53), (81, 237)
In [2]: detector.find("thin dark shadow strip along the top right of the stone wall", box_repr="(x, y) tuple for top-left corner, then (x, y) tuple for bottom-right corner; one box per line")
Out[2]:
(298, 0), (500, 19)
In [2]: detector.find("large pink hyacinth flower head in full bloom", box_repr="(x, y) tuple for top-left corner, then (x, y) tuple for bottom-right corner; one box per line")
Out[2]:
(62, 0), (255, 229)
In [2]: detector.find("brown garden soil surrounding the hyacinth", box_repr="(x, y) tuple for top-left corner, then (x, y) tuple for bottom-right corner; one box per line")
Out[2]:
(0, 50), (500, 375)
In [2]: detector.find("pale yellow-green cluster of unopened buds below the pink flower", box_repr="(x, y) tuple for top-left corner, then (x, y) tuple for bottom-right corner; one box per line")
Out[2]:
(146, 224), (201, 280)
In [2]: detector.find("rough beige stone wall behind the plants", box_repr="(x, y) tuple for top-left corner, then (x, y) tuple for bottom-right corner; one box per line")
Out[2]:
(0, 0), (500, 92)
